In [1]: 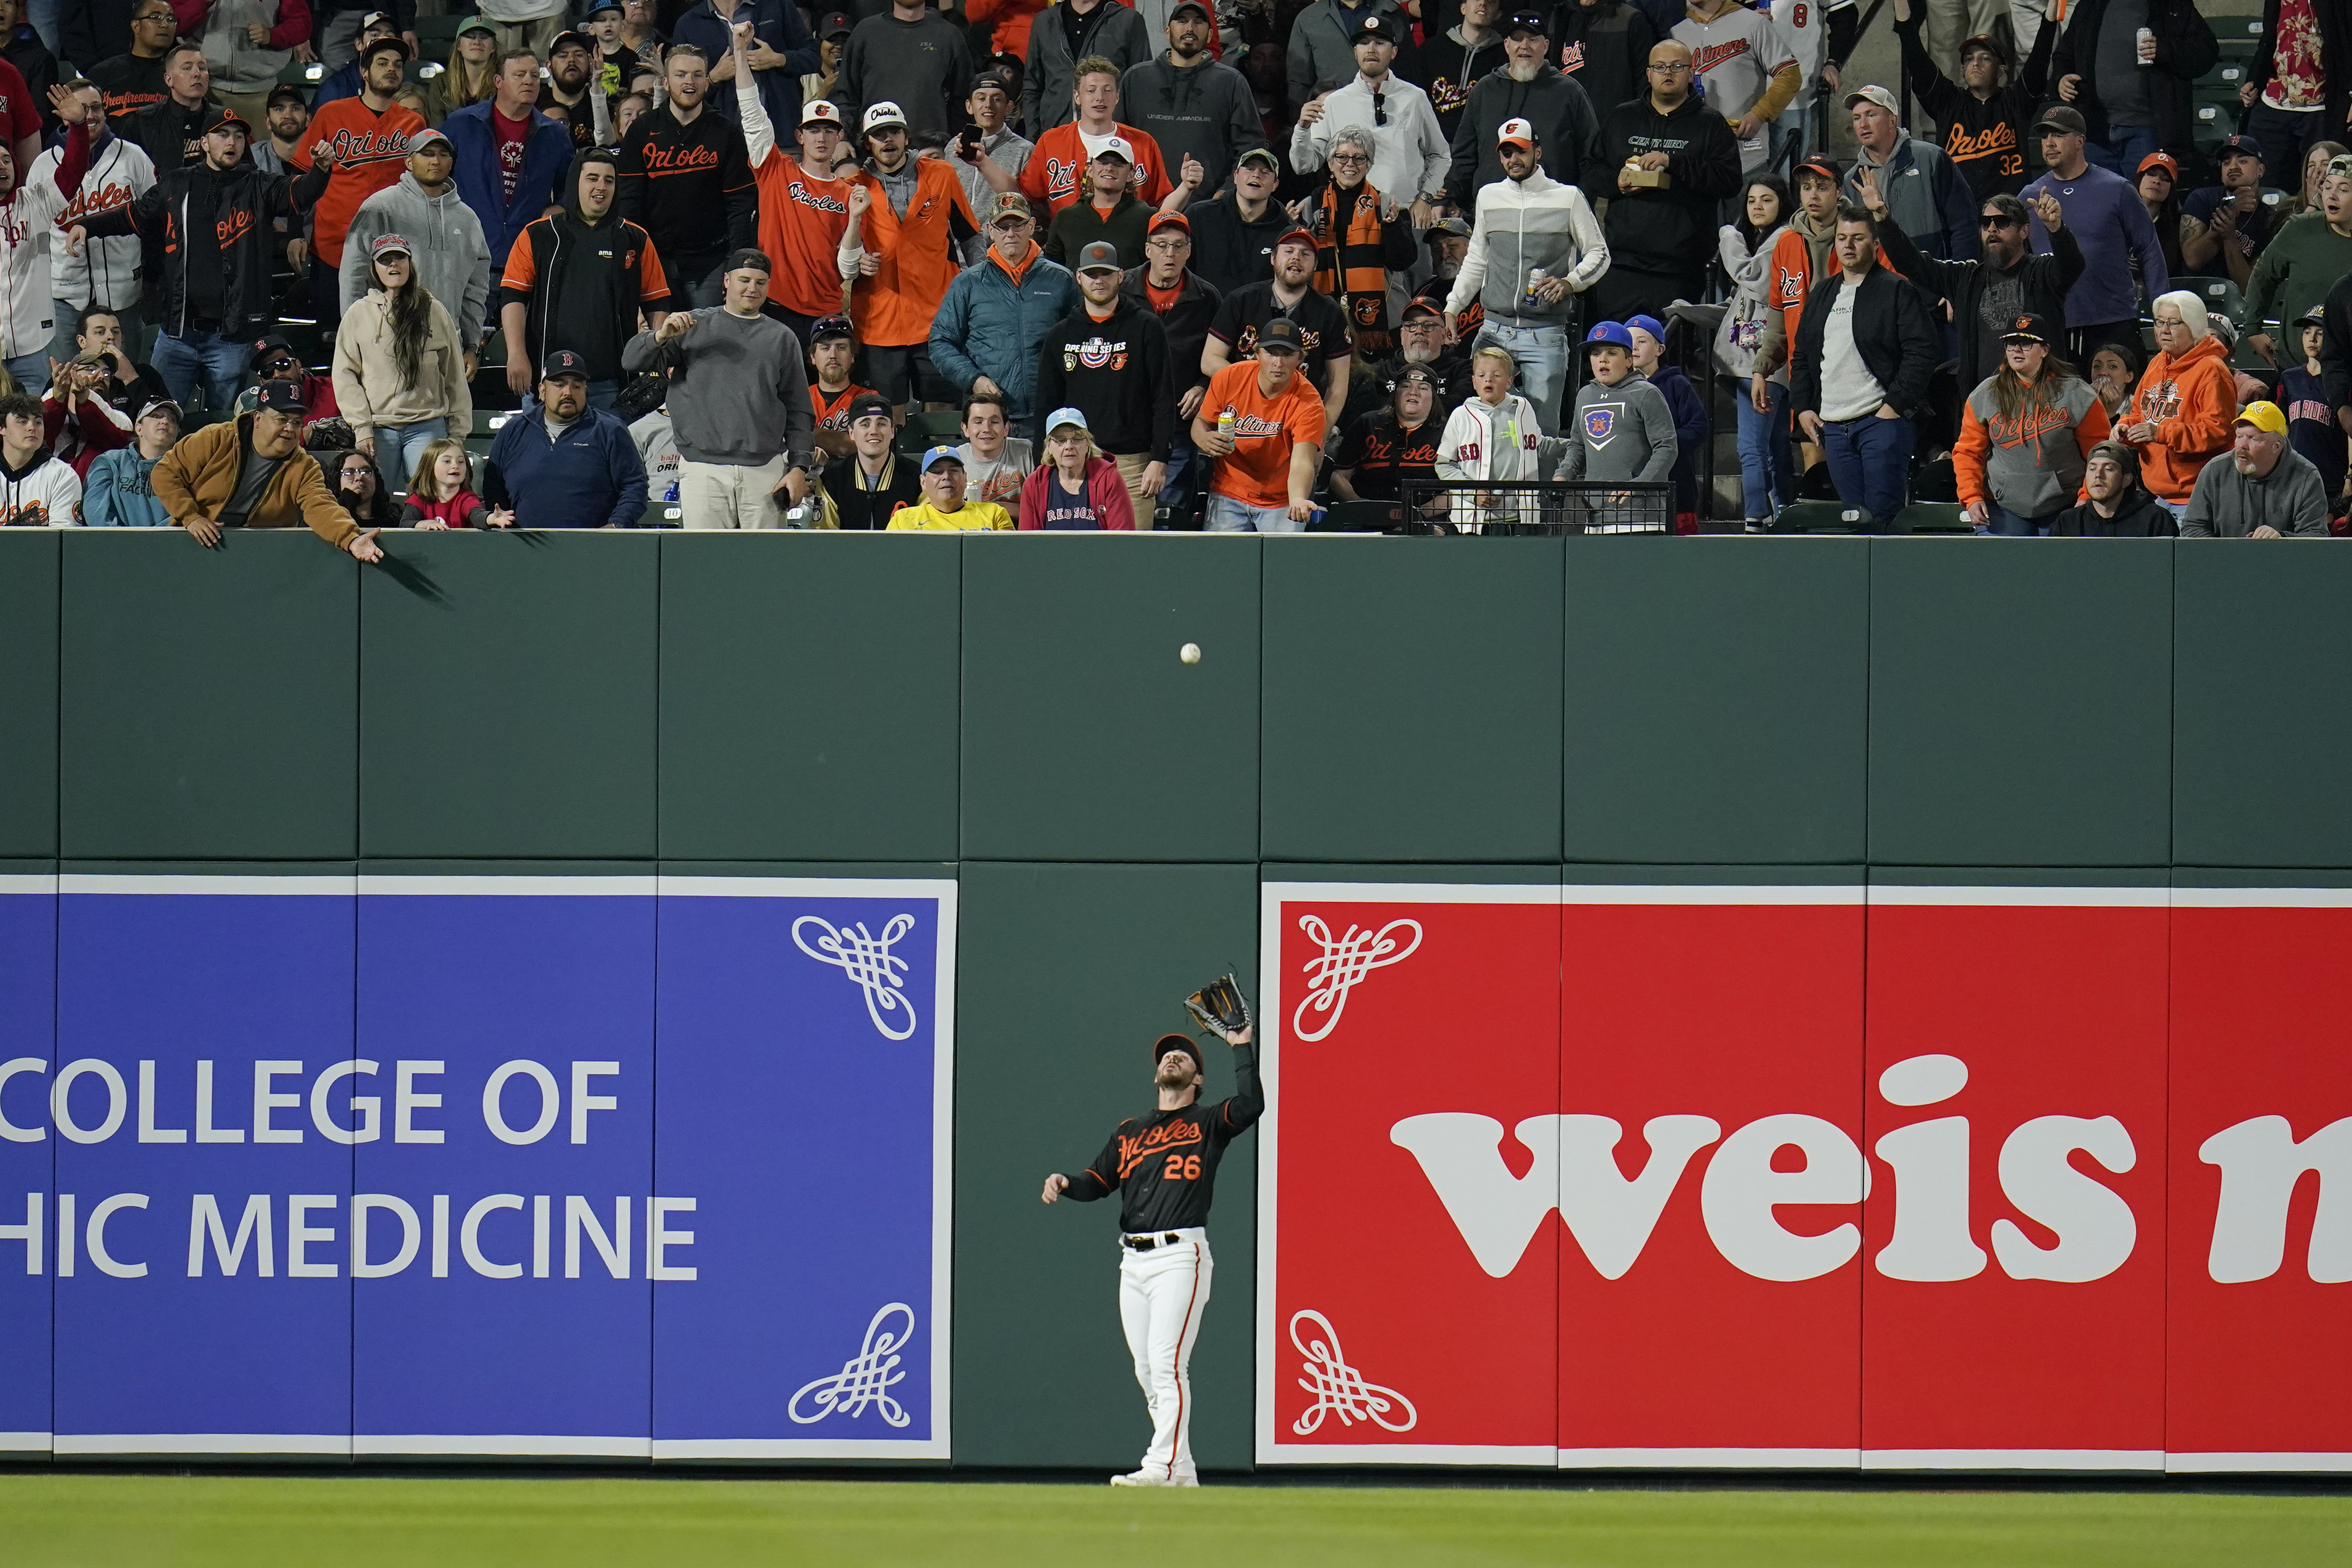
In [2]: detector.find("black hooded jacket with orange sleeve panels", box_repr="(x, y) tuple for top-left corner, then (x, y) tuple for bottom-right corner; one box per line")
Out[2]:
(506, 151), (672, 381)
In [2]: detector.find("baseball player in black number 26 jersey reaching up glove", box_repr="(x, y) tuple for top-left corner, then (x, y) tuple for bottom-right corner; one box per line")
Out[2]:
(1044, 1011), (1265, 1486)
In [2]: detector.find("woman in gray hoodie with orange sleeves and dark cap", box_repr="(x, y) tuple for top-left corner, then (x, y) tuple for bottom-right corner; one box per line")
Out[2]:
(1952, 315), (2107, 538)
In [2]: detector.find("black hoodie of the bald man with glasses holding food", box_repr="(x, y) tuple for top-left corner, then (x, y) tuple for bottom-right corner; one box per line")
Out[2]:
(1578, 92), (1741, 278)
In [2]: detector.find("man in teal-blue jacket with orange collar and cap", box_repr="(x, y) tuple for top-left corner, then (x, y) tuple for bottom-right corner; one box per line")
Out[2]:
(932, 191), (1077, 428)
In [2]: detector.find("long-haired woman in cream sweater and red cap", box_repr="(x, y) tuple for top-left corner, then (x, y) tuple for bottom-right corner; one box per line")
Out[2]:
(334, 235), (473, 475)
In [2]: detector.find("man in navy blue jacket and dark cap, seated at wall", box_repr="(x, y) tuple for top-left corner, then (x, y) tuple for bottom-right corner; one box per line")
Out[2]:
(482, 348), (644, 529)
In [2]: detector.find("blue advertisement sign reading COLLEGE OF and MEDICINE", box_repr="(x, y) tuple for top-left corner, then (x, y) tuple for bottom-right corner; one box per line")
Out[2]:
(0, 874), (955, 1458)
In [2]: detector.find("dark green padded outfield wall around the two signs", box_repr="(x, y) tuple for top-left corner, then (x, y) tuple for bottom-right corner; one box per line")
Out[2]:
(0, 529), (2352, 1469)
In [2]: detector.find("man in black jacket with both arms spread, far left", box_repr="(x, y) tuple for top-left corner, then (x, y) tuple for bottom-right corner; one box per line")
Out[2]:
(66, 115), (336, 414)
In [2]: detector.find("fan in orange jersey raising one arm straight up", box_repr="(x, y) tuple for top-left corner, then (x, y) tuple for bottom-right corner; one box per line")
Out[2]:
(734, 21), (849, 348)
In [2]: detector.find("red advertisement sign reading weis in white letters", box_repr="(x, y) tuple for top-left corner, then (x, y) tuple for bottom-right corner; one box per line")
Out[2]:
(1256, 884), (2352, 1469)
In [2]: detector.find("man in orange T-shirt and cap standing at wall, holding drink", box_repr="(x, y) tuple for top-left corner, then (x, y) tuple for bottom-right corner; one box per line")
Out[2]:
(1193, 315), (1324, 533)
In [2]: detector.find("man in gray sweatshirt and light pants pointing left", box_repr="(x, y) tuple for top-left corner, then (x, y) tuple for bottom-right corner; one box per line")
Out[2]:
(621, 249), (814, 529)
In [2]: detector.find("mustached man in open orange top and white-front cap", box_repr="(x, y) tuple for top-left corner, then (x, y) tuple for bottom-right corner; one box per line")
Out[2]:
(840, 99), (981, 421)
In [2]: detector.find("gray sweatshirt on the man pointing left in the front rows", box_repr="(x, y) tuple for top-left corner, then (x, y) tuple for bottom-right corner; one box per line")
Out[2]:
(621, 311), (812, 468)
